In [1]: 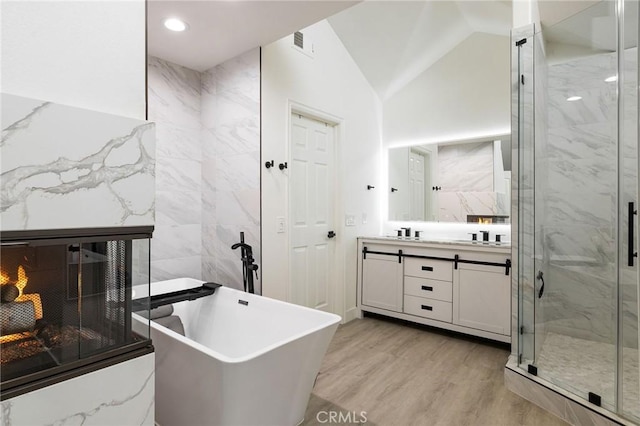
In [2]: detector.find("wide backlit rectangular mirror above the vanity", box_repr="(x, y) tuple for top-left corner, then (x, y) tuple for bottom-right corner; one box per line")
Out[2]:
(388, 134), (511, 223)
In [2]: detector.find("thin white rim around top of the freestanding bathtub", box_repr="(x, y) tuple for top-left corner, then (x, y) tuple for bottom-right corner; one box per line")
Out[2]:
(132, 278), (342, 364)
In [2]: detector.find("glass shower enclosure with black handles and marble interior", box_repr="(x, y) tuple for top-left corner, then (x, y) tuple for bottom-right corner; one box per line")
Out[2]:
(513, 0), (640, 422)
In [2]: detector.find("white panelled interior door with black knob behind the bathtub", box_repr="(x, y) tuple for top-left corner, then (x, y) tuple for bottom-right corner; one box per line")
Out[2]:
(289, 113), (336, 313)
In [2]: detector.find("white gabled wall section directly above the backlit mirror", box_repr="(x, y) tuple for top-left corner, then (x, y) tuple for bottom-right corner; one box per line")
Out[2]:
(384, 33), (511, 146)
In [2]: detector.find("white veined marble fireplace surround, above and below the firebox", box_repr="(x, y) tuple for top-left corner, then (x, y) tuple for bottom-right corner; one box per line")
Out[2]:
(0, 93), (155, 425)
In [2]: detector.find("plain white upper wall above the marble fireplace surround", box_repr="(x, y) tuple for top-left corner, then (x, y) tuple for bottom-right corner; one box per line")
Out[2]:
(0, 0), (146, 119)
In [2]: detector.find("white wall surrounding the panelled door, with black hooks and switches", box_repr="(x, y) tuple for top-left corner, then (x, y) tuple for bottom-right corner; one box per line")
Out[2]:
(261, 21), (382, 320)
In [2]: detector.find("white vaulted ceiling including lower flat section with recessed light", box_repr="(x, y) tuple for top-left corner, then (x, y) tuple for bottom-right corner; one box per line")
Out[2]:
(147, 0), (615, 99)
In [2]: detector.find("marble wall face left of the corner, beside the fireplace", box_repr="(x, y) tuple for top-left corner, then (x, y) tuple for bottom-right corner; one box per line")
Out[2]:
(147, 57), (202, 282)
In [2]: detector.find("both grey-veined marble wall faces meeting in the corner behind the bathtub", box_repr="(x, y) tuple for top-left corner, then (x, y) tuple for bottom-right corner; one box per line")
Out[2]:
(148, 49), (260, 290)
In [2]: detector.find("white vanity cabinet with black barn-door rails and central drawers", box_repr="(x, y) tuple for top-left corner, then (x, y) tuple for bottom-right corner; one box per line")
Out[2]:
(357, 238), (511, 342)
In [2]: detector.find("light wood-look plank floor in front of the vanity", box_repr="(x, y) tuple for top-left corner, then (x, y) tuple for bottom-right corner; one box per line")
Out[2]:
(303, 317), (566, 426)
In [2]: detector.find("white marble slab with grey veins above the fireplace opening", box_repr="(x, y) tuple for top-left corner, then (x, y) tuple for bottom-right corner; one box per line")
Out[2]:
(0, 94), (155, 230)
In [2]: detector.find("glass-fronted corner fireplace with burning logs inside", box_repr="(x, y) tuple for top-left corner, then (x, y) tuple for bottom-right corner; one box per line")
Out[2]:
(0, 231), (150, 393)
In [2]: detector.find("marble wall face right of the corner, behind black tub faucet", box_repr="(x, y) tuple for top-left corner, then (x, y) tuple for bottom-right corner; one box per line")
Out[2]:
(202, 49), (261, 292)
